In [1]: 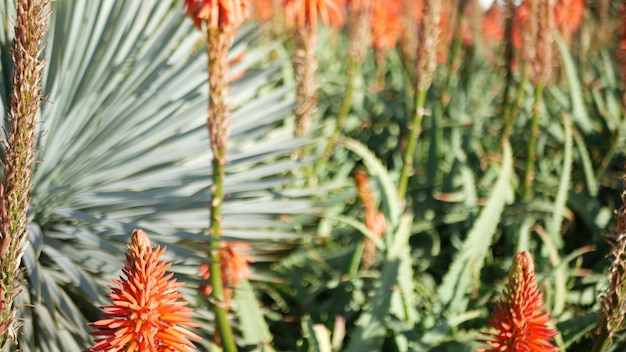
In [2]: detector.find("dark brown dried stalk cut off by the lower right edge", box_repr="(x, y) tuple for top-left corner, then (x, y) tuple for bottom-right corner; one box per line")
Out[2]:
(593, 191), (626, 352)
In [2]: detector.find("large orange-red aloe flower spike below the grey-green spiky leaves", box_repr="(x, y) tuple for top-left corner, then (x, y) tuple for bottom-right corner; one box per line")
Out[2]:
(86, 230), (201, 352)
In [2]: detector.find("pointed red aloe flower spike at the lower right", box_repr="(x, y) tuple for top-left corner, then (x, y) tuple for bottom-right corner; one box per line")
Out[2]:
(478, 252), (558, 352)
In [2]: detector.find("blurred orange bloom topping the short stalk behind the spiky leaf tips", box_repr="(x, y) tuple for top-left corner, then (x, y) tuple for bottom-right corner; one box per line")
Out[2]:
(284, 0), (344, 29)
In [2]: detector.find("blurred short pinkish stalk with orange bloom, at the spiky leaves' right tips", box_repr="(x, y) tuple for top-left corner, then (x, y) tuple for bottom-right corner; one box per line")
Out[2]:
(284, 0), (343, 136)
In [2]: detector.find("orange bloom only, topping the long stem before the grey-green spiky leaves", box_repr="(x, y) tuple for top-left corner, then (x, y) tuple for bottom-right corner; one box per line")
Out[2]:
(184, 0), (250, 28)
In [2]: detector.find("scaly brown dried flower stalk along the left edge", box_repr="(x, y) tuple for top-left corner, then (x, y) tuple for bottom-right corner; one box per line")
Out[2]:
(0, 0), (50, 347)
